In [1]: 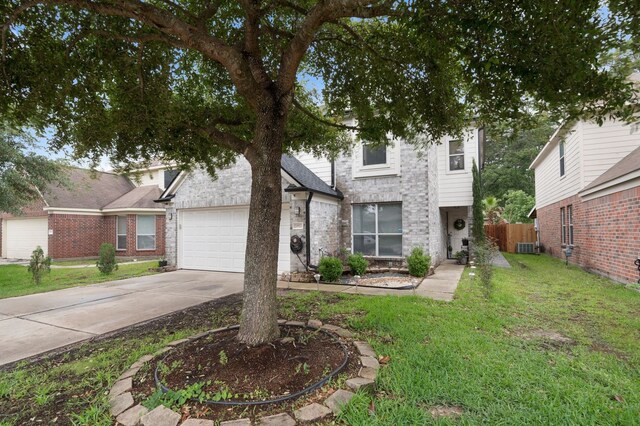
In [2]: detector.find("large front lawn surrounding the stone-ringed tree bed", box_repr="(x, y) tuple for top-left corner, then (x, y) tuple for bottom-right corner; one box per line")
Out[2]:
(0, 255), (640, 425)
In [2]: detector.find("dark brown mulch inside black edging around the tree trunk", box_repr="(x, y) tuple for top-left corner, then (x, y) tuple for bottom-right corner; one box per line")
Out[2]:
(160, 327), (345, 401)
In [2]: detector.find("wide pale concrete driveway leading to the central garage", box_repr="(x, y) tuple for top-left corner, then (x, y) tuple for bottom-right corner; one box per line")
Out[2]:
(0, 271), (244, 365)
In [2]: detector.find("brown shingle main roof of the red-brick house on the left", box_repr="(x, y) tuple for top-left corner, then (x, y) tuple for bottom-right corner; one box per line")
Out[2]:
(42, 168), (135, 209)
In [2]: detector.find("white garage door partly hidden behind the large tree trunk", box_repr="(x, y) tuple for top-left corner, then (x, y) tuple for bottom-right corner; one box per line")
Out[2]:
(178, 204), (290, 272)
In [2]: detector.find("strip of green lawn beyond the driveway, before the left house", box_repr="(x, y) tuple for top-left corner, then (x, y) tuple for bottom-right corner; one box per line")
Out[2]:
(0, 262), (158, 299)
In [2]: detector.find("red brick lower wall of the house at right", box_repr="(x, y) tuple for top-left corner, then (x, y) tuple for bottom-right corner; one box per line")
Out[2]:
(537, 186), (640, 283)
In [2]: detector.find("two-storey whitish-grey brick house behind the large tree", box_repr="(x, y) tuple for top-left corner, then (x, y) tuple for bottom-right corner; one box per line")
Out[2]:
(158, 125), (483, 273)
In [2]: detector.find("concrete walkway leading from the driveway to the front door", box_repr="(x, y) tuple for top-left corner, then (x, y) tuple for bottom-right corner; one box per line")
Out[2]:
(278, 260), (464, 302)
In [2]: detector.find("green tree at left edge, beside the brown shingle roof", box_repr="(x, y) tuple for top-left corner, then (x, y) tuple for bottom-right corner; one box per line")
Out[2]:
(0, 129), (66, 215)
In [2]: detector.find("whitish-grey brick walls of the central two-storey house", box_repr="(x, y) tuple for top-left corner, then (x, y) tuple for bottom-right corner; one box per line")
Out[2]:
(166, 142), (464, 271)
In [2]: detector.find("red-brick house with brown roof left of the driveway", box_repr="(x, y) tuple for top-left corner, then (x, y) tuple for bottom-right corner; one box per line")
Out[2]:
(0, 165), (170, 259)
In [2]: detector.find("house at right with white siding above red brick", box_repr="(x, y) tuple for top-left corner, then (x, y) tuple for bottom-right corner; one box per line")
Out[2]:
(530, 120), (640, 282)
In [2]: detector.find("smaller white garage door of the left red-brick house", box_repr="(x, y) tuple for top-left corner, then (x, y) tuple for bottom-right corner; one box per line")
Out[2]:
(5, 217), (49, 259)
